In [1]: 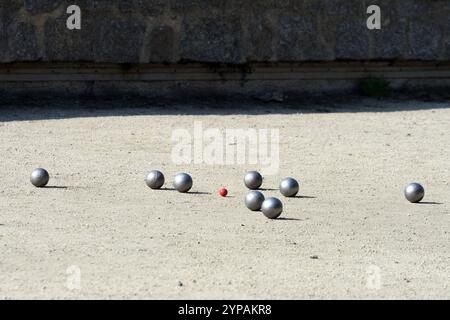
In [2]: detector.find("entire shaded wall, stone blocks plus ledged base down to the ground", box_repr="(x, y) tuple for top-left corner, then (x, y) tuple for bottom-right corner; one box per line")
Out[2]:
(0, 0), (450, 96)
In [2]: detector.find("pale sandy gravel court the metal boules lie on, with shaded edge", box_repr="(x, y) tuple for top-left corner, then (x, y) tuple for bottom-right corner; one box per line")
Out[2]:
(0, 99), (450, 299)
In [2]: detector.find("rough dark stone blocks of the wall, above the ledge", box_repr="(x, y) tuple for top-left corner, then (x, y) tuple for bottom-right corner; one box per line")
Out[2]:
(0, 0), (450, 64)
